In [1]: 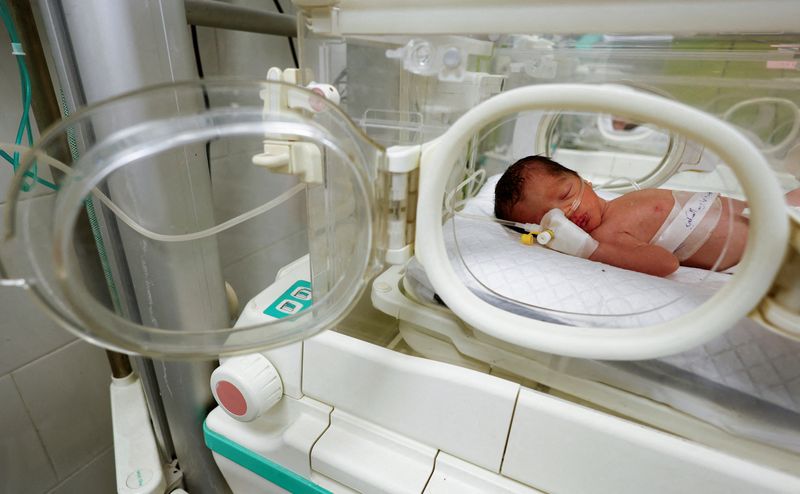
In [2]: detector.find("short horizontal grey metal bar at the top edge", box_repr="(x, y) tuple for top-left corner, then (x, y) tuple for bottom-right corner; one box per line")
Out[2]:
(185, 0), (297, 38)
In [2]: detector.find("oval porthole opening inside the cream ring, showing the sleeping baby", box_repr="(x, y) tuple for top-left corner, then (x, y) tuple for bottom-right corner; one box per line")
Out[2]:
(440, 103), (760, 328)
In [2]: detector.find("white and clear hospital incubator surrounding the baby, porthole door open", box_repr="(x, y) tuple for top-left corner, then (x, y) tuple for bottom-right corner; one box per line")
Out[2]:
(0, 0), (800, 492)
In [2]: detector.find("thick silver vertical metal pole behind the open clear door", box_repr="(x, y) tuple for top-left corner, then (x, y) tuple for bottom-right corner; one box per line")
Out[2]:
(32, 0), (229, 494)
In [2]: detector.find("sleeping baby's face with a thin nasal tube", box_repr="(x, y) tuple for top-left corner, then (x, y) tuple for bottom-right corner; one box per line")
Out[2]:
(512, 172), (602, 232)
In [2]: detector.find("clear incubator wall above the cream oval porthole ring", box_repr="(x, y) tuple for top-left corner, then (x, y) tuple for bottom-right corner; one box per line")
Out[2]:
(301, 30), (800, 177)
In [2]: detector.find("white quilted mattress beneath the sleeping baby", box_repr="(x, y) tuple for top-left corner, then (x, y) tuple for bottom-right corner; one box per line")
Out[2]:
(407, 178), (800, 428)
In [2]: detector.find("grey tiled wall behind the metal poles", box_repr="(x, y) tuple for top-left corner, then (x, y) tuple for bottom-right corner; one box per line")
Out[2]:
(0, 0), (306, 494)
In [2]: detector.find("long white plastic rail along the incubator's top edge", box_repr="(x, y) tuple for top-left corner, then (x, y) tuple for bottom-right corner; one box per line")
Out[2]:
(294, 0), (800, 35)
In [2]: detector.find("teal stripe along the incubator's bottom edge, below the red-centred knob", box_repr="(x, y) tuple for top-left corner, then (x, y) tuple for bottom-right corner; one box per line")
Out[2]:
(203, 420), (333, 494)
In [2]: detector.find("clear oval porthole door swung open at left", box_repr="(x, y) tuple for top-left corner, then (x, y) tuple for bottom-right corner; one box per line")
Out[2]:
(2, 82), (384, 358)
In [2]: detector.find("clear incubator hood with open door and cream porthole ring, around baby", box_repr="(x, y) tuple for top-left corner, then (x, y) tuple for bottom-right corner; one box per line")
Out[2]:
(2, 2), (800, 360)
